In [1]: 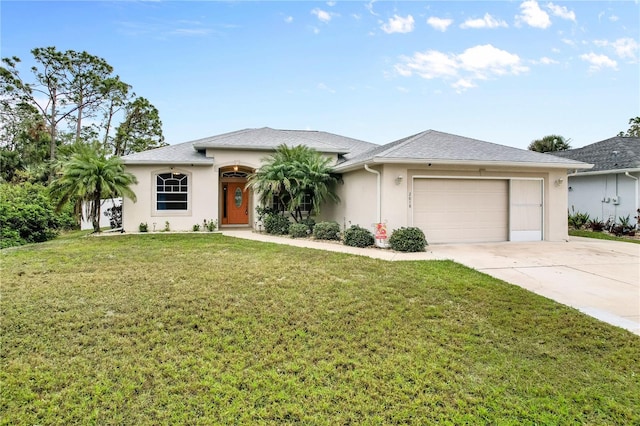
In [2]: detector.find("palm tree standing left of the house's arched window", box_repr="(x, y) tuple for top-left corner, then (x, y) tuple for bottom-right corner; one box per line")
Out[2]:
(51, 146), (137, 232)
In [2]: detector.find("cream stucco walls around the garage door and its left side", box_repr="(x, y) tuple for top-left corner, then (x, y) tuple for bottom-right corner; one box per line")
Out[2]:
(330, 164), (567, 241)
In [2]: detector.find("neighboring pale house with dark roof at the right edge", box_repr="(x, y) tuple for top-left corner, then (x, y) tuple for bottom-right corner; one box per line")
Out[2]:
(553, 136), (640, 225)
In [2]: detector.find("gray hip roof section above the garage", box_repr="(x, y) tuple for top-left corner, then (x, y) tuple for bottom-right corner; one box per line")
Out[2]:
(337, 130), (588, 171)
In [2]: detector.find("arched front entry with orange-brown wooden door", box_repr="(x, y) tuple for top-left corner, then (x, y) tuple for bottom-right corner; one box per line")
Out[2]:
(220, 166), (251, 225)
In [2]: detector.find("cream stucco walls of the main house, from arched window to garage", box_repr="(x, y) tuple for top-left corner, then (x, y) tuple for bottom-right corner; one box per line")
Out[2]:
(123, 149), (567, 241)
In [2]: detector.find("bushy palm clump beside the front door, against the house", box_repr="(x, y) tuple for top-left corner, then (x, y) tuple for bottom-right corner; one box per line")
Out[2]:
(247, 145), (340, 222)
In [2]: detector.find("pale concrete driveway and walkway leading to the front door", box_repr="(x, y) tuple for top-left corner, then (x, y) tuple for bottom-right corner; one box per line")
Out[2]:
(222, 229), (640, 335)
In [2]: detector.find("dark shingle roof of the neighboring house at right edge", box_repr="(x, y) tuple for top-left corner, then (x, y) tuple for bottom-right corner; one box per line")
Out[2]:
(553, 136), (640, 173)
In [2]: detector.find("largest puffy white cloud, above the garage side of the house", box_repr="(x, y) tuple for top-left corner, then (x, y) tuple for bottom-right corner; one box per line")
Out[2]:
(394, 44), (529, 91)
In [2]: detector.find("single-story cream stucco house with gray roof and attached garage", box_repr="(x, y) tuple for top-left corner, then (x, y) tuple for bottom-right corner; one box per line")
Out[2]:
(123, 128), (590, 243)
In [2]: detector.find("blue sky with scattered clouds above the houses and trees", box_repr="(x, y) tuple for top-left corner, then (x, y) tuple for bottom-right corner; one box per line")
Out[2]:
(0, 0), (640, 148)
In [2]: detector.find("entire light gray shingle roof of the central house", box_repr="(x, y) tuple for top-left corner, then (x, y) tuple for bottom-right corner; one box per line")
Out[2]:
(122, 127), (587, 171)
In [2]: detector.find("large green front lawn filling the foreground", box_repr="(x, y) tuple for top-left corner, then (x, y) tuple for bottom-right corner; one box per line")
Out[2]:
(0, 234), (640, 425)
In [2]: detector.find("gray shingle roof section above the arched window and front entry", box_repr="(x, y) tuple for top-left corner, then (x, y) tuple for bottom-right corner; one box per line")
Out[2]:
(122, 127), (377, 165)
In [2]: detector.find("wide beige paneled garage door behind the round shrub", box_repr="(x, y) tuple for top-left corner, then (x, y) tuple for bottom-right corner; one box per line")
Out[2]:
(413, 178), (509, 243)
